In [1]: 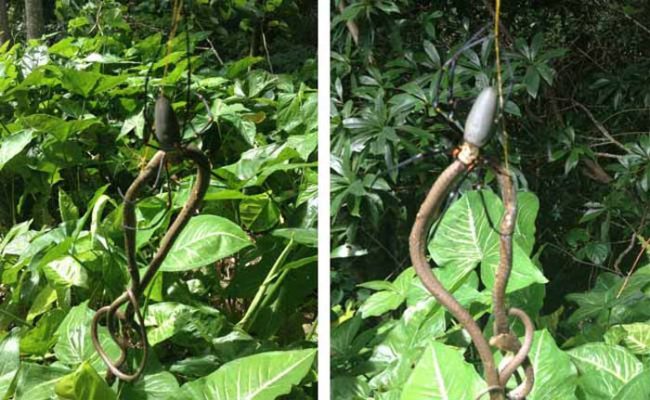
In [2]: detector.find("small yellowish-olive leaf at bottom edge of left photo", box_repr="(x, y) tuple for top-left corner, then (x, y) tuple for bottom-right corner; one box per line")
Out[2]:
(54, 362), (117, 400)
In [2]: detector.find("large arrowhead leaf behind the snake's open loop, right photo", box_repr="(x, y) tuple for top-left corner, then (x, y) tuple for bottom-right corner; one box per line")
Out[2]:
(429, 191), (548, 293)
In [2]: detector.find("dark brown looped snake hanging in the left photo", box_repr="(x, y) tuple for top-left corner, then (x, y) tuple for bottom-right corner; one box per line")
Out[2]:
(91, 146), (211, 381)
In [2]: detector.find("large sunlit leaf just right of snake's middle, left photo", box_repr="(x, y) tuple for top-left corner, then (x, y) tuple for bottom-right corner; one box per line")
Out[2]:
(161, 215), (253, 271)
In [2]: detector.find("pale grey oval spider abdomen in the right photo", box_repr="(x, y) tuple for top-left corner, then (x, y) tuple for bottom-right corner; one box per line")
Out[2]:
(463, 86), (497, 147)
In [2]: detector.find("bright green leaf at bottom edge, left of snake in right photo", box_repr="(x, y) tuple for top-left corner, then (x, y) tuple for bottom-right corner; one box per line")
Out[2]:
(400, 342), (485, 400)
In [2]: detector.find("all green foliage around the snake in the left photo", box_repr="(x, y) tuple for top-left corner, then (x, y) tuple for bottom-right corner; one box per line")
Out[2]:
(0, 0), (317, 400)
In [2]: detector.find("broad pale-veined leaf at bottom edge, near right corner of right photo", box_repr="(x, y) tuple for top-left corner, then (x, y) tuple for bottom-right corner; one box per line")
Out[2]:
(568, 343), (643, 399)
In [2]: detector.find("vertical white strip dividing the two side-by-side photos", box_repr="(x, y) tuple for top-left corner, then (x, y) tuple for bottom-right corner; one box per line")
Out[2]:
(318, 0), (330, 400)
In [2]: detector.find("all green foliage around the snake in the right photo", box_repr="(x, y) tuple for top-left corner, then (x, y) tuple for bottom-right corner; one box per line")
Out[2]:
(331, 0), (650, 400)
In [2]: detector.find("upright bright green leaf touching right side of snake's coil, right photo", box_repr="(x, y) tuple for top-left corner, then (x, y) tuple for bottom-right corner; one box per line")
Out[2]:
(527, 330), (578, 400)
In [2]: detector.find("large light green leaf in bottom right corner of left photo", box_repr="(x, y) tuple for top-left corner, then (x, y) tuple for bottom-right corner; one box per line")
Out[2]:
(168, 349), (316, 400)
